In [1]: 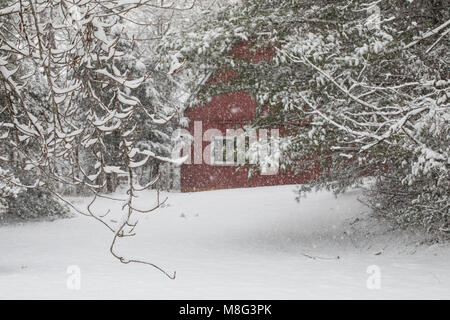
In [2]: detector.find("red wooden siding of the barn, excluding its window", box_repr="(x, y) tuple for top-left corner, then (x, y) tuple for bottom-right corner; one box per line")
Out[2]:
(181, 45), (317, 192)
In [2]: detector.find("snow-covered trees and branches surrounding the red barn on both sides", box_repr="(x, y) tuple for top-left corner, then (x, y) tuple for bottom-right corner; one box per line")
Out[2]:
(0, 0), (450, 270)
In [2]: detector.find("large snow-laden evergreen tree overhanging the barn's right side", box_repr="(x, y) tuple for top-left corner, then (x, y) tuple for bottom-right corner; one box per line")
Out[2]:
(163, 0), (450, 236)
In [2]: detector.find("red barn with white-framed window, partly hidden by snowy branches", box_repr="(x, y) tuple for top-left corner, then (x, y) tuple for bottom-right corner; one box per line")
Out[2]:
(180, 45), (315, 192)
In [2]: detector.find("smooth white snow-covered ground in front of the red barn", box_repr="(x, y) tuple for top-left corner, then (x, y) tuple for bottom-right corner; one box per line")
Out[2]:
(0, 186), (450, 299)
